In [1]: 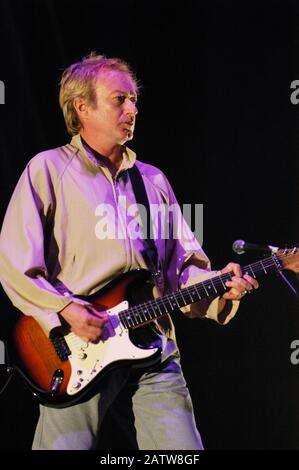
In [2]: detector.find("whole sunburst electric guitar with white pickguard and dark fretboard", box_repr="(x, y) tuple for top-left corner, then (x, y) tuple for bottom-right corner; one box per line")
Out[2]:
(14, 248), (299, 407)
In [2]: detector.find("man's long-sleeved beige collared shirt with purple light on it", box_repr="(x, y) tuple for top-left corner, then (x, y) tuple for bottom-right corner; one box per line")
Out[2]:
(0, 135), (238, 333)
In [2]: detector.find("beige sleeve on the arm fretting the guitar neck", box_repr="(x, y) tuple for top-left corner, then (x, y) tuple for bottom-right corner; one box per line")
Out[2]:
(165, 174), (239, 324)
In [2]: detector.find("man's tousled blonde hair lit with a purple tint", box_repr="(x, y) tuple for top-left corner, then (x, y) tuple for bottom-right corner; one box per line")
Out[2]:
(59, 52), (138, 135)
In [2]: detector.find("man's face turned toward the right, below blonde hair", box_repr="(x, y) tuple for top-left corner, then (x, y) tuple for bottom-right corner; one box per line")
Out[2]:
(84, 70), (137, 145)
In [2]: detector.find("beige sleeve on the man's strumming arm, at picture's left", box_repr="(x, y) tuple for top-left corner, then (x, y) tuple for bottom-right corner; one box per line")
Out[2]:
(0, 157), (71, 333)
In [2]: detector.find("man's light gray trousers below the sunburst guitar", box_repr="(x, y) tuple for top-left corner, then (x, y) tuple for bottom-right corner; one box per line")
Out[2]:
(32, 344), (203, 450)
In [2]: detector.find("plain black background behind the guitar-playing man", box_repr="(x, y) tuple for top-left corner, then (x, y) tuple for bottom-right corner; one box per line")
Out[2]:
(0, 0), (299, 449)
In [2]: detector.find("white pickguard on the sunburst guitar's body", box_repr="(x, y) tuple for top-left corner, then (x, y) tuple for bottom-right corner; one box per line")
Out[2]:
(64, 300), (158, 395)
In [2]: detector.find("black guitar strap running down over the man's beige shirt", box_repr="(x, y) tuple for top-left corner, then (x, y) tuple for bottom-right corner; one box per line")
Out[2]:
(128, 165), (160, 279)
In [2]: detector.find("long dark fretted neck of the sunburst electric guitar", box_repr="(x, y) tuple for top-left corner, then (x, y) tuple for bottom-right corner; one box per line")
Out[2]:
(119, 255), (281, 329)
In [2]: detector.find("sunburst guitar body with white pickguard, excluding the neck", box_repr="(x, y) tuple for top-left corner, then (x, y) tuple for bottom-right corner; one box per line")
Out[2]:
(14, 270), (161, 407)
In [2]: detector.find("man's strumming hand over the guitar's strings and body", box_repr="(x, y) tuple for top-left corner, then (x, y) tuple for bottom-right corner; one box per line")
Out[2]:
(60, 302), (109, 342)
